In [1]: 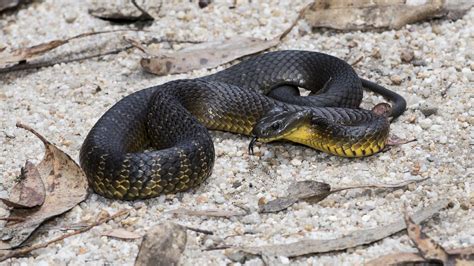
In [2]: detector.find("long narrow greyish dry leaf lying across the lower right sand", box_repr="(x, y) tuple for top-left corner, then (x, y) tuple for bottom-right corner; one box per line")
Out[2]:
(228, 200), (449, 258)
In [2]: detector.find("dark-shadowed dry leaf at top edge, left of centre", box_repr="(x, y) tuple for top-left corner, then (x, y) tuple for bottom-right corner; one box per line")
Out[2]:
(89, 0), (162, 23)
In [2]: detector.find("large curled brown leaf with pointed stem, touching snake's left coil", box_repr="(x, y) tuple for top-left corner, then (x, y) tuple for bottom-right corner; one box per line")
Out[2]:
(0, 123), (88, 249)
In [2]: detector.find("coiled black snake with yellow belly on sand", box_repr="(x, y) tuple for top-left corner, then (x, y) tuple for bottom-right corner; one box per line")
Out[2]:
(79, 50), (406, 200)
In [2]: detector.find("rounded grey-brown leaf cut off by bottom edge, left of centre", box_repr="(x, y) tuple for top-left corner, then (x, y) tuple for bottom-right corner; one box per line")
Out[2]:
(135, 223), (187, 266)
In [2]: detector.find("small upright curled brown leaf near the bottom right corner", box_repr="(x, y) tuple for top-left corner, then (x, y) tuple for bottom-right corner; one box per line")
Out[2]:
(405, 210), (448, 265)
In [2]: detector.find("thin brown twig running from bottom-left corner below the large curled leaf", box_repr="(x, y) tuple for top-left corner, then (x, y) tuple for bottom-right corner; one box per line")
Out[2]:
(0, 210), (129, 261)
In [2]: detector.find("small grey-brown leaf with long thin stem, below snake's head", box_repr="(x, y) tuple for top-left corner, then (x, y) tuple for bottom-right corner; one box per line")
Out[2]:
(259, 178), (428, 213)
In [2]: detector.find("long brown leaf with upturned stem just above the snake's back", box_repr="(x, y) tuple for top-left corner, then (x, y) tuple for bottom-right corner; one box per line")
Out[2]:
(138, 1), (312, 76)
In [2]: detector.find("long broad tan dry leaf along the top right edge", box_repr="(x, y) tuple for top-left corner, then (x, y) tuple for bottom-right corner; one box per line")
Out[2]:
(306, 0), (473, 30)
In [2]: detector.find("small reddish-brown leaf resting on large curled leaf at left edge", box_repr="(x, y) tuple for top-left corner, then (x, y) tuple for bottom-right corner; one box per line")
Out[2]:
(0, 161), (46, 208)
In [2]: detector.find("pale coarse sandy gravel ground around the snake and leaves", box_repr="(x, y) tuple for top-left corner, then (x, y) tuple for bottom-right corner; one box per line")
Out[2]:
(0, 0), (474, 265)
